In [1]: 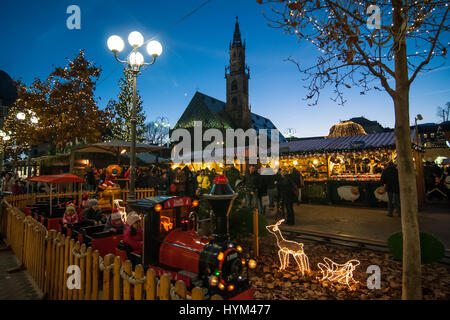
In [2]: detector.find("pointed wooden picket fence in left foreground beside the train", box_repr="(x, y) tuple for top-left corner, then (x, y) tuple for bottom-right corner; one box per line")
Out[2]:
(0, 196), (222, 300)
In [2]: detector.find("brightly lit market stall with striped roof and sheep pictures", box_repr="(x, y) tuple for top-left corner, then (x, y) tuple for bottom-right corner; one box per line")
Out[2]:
(280, 131), (424, 207)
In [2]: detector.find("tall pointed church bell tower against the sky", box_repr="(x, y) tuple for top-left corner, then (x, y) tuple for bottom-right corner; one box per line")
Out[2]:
(225, 17), (252, 130)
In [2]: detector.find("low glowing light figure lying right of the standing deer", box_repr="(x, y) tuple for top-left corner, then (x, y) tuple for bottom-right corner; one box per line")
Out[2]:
(317, 257), (360, 290)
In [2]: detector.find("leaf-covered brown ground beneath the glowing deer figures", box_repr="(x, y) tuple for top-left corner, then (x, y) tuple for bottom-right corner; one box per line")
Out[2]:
(244, 235), (450, 300)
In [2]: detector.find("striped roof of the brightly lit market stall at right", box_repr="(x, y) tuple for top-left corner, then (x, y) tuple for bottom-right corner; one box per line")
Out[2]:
(280, 130), (415, 153)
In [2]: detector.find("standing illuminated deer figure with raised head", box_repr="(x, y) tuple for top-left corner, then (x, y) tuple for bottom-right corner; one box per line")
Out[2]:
(266, 219), (309, 275)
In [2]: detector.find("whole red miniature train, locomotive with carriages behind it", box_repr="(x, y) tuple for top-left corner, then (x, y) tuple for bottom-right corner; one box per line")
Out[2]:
(27, 176), (256, 300)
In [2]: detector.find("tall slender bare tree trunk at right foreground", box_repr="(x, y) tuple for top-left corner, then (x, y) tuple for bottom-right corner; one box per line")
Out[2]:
(392, 0), (422, 300)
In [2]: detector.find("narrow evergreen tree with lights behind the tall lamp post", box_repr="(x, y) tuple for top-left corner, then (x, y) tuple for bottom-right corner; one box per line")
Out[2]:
(108, 68), (146, 143)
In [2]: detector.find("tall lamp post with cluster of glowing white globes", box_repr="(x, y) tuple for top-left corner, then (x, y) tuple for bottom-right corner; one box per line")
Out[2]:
(108, 31), (162, 203)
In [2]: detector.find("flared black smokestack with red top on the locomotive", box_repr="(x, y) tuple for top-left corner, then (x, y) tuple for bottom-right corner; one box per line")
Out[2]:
(203, 175), (238, 240)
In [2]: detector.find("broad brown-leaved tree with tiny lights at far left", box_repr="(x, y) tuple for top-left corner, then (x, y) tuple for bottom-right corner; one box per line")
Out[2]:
(2, 51), (110, 155)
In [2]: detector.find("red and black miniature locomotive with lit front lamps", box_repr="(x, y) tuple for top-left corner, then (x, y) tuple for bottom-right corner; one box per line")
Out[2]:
(125, 176), (256, 300)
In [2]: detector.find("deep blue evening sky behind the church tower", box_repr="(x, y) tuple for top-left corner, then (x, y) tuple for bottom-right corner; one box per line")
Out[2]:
(0, 0), (450, 137)
